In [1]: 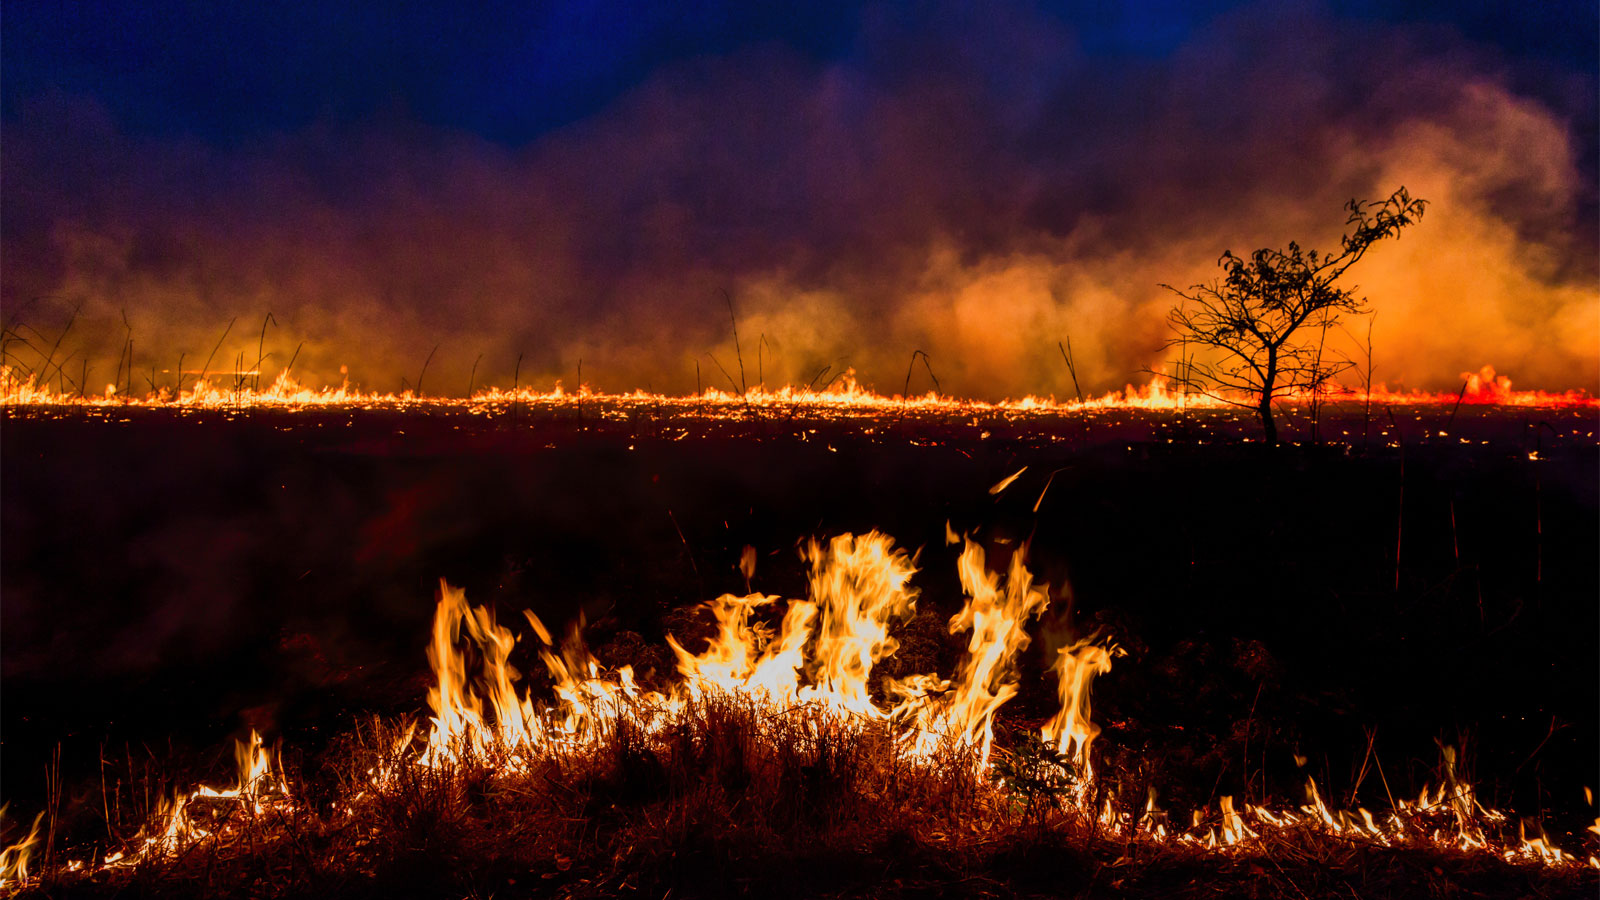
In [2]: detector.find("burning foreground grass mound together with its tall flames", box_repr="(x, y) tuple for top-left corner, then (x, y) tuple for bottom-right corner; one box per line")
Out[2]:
(6, 533), (1600, 897)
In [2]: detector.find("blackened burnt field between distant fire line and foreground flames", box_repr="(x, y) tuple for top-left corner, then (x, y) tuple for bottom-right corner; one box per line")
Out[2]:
(0, 400), (1600, 895)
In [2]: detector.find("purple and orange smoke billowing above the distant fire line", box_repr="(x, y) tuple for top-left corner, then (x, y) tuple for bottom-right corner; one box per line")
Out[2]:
(0, 6), (1600, 397)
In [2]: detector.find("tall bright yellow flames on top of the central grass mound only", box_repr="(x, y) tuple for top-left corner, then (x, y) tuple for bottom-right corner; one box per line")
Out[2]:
(418, 532), (1075, 772)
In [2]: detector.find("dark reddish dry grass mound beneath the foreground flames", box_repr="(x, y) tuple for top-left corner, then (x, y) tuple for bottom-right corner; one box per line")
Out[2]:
(15, 697), (1597, 898)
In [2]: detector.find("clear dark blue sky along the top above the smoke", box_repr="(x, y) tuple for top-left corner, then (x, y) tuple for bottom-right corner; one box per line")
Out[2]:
(0, 0), (1597, 144)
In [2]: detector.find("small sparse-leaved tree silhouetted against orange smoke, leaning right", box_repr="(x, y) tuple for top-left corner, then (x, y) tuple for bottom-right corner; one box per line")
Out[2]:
(1162, 187), (1427, 445)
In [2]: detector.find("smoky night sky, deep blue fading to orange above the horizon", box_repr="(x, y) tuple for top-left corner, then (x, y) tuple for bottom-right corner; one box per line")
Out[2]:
(0, 2), (1600, 397)
